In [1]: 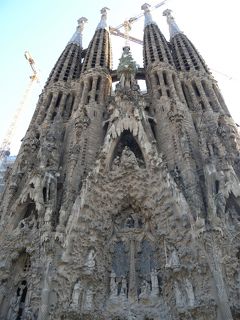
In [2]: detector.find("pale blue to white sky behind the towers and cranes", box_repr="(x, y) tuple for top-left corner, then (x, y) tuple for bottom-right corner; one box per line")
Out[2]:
(0, 0), (240, 153)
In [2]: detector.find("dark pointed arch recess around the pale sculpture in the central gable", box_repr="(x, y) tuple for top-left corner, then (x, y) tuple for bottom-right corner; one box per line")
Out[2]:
(112, 130), (146, 167)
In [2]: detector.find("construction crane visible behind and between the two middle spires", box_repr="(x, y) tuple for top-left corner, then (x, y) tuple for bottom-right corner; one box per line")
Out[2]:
(109, 0), (168, 46)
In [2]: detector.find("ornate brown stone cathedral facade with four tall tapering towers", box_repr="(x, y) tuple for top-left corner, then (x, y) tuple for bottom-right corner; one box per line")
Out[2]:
(0, 4), (240, 320)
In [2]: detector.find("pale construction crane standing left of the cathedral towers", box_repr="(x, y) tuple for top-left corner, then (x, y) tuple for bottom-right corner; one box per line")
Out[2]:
(0, 51), (39, 162)
